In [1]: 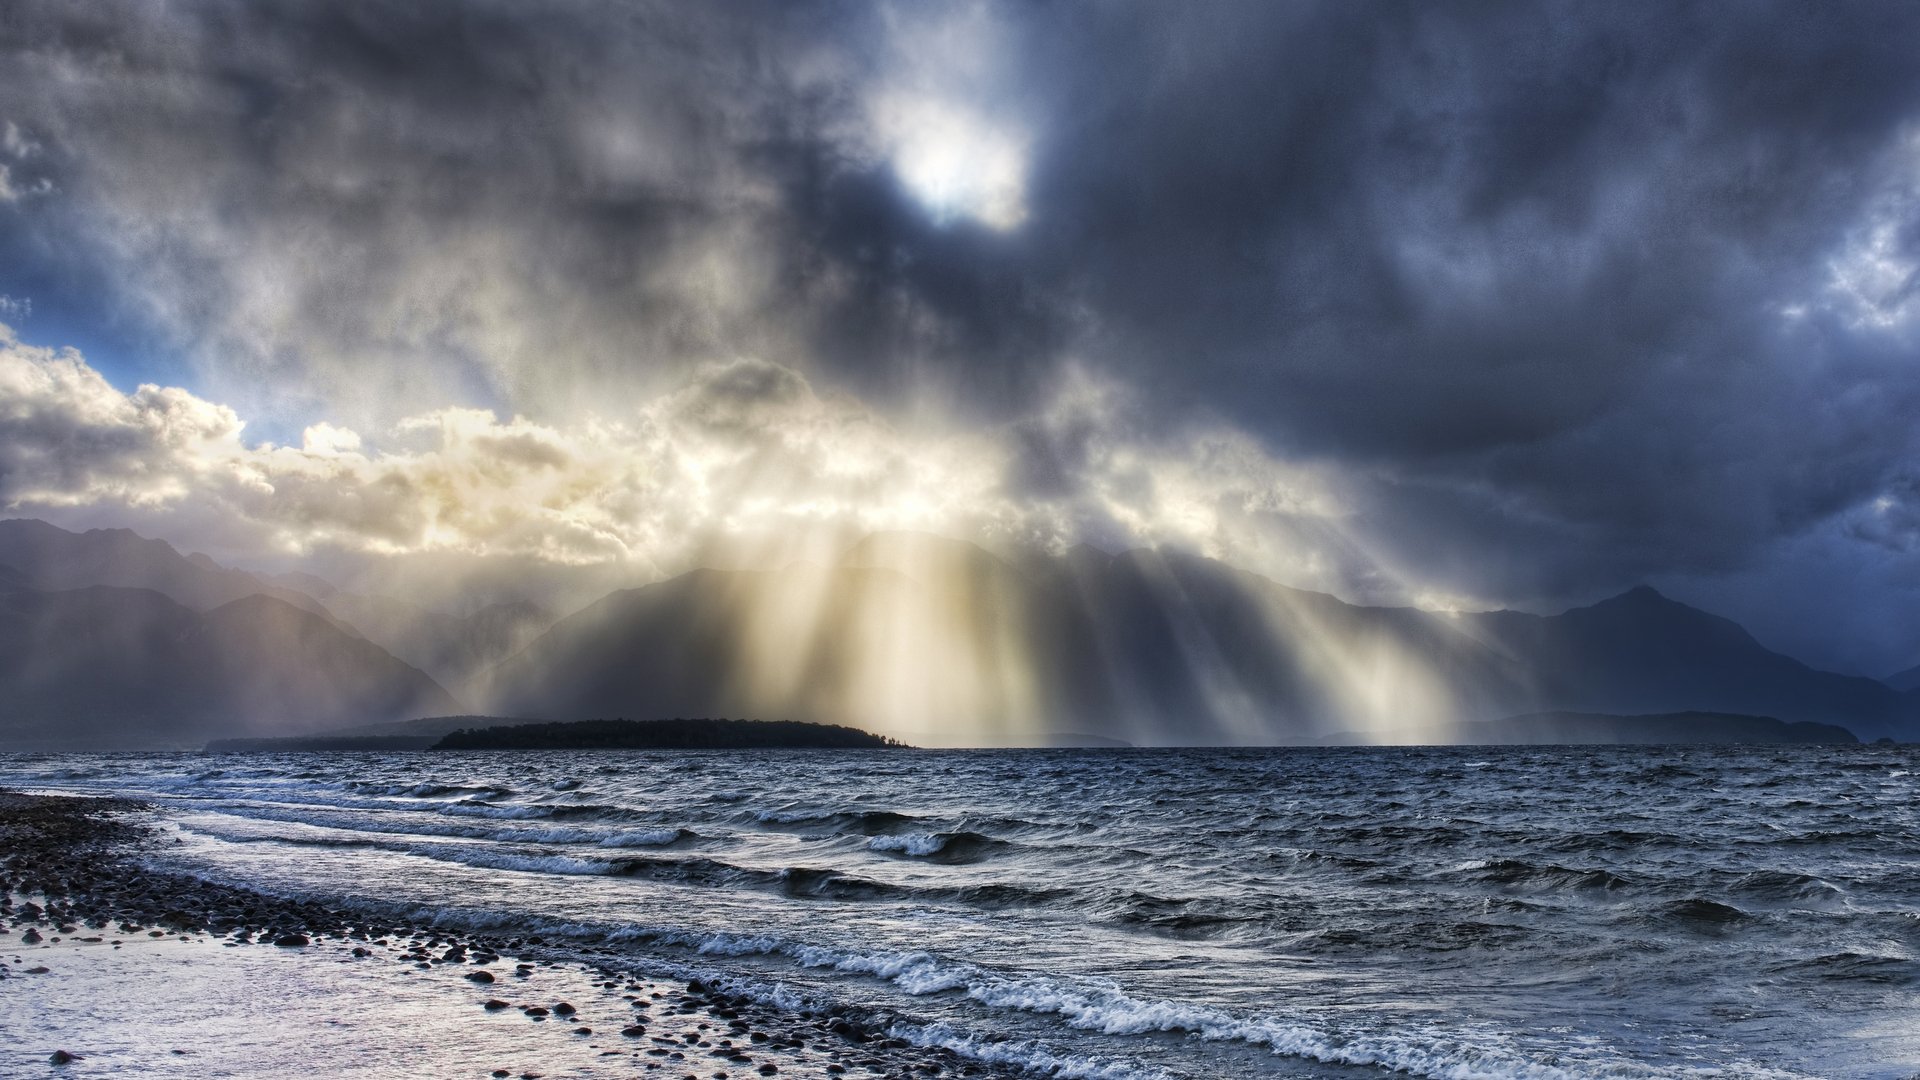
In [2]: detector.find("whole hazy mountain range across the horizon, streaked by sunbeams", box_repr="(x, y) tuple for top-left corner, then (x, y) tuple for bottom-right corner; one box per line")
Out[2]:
(0, 519), (1920, 749)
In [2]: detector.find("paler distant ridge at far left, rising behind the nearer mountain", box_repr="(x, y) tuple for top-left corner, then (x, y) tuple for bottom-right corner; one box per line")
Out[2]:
(0, 517), (351, 632)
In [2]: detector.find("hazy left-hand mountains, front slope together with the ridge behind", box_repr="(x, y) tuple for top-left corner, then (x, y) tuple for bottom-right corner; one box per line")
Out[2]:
(0, 519), (553, 746)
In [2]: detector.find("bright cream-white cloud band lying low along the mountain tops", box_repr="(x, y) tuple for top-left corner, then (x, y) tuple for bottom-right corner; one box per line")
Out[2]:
(0, 319), (1390, 588)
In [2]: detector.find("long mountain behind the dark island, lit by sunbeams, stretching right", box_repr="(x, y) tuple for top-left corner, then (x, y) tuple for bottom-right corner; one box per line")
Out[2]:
(490, 534), (1920, 746)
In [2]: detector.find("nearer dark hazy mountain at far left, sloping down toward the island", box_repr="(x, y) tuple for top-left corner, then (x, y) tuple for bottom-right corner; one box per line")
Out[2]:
(0, 586), (461, 749)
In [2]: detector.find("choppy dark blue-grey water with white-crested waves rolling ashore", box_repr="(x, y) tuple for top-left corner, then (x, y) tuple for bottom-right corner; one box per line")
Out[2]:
(0, 748), (1920, 1078)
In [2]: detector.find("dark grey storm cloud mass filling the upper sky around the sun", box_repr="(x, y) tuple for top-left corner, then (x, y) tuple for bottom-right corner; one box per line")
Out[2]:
(0, 2), (1920, 663)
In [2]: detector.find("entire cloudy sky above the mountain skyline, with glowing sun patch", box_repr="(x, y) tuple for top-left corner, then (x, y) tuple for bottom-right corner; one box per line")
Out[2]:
(0, 0), (1920, 675)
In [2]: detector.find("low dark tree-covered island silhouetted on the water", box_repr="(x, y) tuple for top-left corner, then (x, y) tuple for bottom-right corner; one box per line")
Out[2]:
(434, 717), (906, 749)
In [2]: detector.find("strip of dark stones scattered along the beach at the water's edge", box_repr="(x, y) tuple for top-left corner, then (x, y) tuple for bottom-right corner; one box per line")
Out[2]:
(0, 780), (1010, 1078)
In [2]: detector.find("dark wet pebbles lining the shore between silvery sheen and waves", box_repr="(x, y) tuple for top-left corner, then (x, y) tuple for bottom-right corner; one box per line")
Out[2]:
(0, 792), (1018, 1080)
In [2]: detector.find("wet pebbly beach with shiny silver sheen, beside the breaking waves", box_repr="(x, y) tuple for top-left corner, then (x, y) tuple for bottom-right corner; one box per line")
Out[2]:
(0, 790), (1023, 1080)
